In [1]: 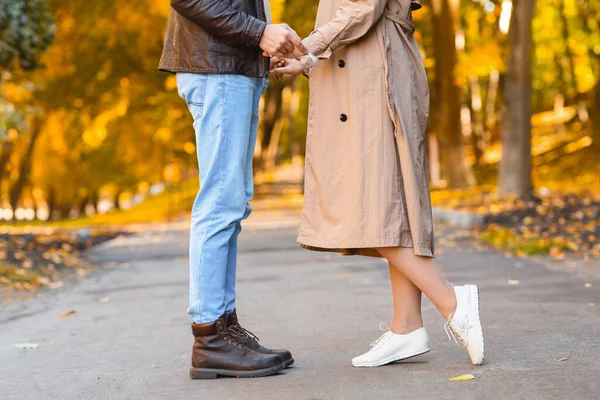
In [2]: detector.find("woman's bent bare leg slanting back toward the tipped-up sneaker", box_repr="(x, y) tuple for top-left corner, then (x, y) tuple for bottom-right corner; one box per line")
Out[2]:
(377, 247), (456, 320)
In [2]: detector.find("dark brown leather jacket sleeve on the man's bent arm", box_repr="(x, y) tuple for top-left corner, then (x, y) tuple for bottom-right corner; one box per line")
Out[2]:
(171, 0), (267, 46)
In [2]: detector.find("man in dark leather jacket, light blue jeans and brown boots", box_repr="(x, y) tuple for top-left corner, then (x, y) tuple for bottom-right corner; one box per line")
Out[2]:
(159, 0), (306, 379)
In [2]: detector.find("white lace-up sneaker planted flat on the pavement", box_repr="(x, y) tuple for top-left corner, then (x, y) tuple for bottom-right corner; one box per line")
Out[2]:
(352, 322), (430, 367)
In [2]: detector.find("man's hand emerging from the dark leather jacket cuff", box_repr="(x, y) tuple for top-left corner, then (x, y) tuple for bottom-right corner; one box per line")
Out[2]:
(259, 24), (307, 58)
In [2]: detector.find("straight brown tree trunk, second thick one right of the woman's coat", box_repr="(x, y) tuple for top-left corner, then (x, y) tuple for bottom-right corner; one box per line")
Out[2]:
(499, 0), (535, 199)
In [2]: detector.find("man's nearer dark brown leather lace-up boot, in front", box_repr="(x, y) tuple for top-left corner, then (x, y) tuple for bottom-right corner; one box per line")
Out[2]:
(190, 315), (285, 379)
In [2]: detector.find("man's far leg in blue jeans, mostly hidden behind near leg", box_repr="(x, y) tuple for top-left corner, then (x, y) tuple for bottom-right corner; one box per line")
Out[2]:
(225, 79), (268, 313)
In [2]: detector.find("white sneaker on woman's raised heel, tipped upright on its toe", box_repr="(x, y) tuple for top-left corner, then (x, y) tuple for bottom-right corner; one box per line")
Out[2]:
(444, 285), (483, 365)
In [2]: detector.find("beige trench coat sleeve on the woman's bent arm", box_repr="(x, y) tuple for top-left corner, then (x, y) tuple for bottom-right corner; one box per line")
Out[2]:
(303, 0), (387, 58)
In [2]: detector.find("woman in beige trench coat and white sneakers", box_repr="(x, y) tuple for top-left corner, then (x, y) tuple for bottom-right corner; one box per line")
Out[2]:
(272, 0), (484, 367)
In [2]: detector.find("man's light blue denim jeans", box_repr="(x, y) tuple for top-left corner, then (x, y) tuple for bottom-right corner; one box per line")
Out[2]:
(177, 73), (268, 323)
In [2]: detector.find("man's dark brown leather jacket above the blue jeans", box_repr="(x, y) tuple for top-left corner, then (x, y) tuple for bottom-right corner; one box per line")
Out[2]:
(158, 0), (269, 78)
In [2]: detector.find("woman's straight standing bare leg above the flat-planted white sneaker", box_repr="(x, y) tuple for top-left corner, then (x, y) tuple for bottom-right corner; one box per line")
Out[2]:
(389, 263), (423, 335)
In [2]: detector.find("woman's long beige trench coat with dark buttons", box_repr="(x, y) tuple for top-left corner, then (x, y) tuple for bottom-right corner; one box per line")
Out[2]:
(298, 0), (434, 257)
